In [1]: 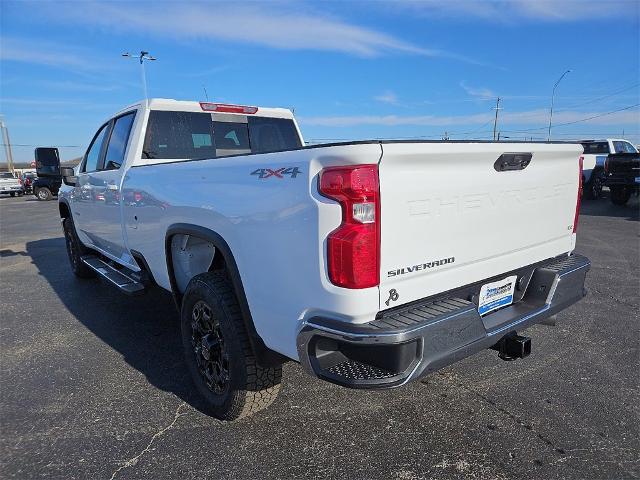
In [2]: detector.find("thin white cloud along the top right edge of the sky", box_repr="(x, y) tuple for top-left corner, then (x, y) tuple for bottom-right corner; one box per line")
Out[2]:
(388, 0), (640, 22)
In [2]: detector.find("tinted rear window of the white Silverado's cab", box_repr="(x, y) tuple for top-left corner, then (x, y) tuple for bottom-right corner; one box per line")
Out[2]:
(142, 110), (302, 160)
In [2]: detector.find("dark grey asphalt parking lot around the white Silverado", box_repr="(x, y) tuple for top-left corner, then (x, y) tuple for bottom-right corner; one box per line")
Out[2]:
(0, 193), (640, 480)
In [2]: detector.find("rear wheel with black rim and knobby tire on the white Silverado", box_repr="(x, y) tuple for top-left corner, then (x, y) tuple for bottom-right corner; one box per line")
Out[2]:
(180, 272), (282, 420)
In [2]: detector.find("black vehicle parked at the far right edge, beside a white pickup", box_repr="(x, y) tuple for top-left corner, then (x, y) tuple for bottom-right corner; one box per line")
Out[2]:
(604, 153), (640, 205)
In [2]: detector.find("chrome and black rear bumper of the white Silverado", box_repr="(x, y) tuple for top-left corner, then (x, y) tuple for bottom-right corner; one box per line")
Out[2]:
(297, 255), (591, 388)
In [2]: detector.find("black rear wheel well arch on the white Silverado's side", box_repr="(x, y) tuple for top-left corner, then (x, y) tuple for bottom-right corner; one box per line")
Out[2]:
(165, 223), (286, 367)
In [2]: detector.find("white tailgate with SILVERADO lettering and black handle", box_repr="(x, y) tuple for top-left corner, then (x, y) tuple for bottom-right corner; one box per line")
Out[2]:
(379, 142), (582, 309)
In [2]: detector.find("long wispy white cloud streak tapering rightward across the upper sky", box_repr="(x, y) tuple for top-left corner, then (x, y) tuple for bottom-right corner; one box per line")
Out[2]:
(31, 1), (480, 64)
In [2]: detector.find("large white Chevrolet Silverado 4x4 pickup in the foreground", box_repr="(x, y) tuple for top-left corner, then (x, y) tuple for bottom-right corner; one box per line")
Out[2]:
(43, 99), (590, 420)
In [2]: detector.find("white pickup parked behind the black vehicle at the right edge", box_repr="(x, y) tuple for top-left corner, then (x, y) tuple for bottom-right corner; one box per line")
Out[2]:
(581, 138), (638, 199)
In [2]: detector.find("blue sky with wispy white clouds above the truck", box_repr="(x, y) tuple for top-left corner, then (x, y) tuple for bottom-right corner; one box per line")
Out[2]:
(0, 0), (640, 161)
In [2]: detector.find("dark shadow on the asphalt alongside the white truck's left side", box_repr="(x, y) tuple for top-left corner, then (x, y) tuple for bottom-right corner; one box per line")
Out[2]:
(26, 238), (214, 412)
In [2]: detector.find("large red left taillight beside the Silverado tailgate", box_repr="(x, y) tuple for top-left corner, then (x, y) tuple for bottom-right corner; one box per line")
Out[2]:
(319, 165), (380, 288)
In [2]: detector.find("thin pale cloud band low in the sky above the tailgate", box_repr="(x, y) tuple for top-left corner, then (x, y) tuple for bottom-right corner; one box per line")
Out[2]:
(298, 108), (640, 127)
